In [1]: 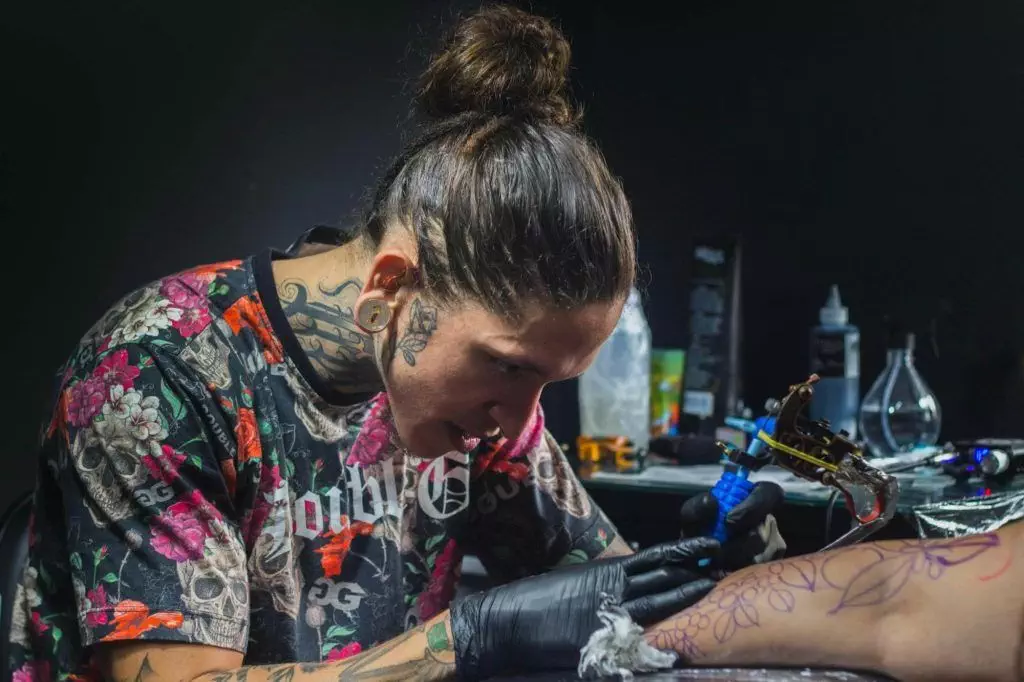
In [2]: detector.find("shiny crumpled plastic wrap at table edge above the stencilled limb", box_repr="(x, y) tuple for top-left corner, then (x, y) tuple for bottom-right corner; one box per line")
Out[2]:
(913, 491), (1024, 538)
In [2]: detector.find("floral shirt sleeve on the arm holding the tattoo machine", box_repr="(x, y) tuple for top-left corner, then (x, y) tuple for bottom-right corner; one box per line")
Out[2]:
(467, 408), (618, 581)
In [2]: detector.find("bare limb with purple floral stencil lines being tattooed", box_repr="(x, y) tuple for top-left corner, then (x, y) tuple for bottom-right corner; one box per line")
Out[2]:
(648, 526), (1024, 682)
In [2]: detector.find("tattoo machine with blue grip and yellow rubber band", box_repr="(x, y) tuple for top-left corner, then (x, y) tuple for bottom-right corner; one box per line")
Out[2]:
(711, 375), (899, 550)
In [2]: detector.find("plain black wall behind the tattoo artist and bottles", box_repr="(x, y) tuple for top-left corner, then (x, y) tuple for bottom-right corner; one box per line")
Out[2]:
(0, 0), (1024, 504)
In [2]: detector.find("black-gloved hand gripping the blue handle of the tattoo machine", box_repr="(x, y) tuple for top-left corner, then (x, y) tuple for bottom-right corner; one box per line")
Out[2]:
(679, 481), (785, 570)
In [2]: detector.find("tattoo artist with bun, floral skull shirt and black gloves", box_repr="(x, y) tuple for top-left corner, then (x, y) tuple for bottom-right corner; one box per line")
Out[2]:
(5, 6), (784, 682)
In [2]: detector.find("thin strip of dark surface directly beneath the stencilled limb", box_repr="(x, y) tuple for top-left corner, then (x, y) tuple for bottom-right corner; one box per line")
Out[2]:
(493, 668), (892, 682)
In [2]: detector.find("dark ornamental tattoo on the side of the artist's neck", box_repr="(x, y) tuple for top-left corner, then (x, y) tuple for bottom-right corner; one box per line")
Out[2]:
(278, 279), (381, 392)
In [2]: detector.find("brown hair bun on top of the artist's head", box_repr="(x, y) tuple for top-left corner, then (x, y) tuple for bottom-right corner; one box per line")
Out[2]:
(417, 5), (580, 126)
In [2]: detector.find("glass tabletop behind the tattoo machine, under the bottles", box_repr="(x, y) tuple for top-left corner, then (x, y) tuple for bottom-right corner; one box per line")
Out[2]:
(580, 464), (1024, 513)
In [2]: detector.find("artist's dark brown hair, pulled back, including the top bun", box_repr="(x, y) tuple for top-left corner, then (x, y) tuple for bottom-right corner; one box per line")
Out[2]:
(364, 6), (636, 316)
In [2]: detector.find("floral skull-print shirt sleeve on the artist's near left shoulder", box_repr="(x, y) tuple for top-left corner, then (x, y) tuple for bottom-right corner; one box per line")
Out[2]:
(43, 345), (249, 652)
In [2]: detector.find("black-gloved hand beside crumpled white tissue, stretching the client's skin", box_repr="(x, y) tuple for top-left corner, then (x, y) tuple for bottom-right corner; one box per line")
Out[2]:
(451, 538), (719, 680)
